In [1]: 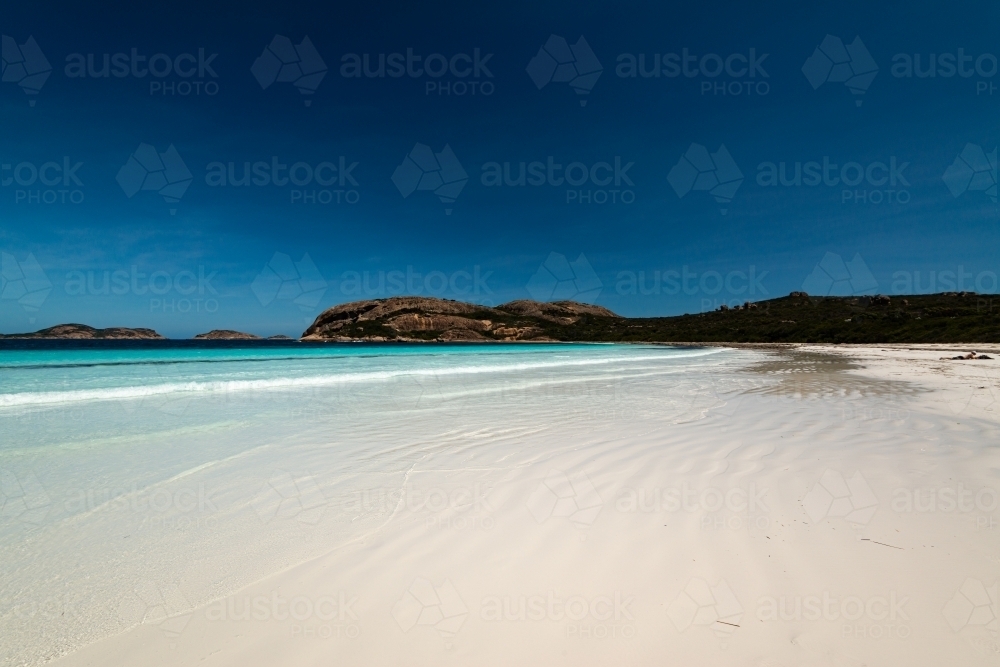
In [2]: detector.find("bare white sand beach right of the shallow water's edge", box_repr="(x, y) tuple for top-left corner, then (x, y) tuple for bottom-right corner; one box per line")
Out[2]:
(29, 346), (1000, 667)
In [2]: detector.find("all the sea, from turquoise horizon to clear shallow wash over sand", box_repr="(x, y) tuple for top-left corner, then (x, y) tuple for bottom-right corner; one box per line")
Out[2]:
(0, 344), (731, 663)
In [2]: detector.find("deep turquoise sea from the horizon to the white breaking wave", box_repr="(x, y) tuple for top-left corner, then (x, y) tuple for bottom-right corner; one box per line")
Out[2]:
(0, 345), (707, 408)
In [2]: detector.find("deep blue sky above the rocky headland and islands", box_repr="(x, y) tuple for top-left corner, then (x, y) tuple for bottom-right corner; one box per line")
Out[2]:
(0, 2), (1000, 337)
